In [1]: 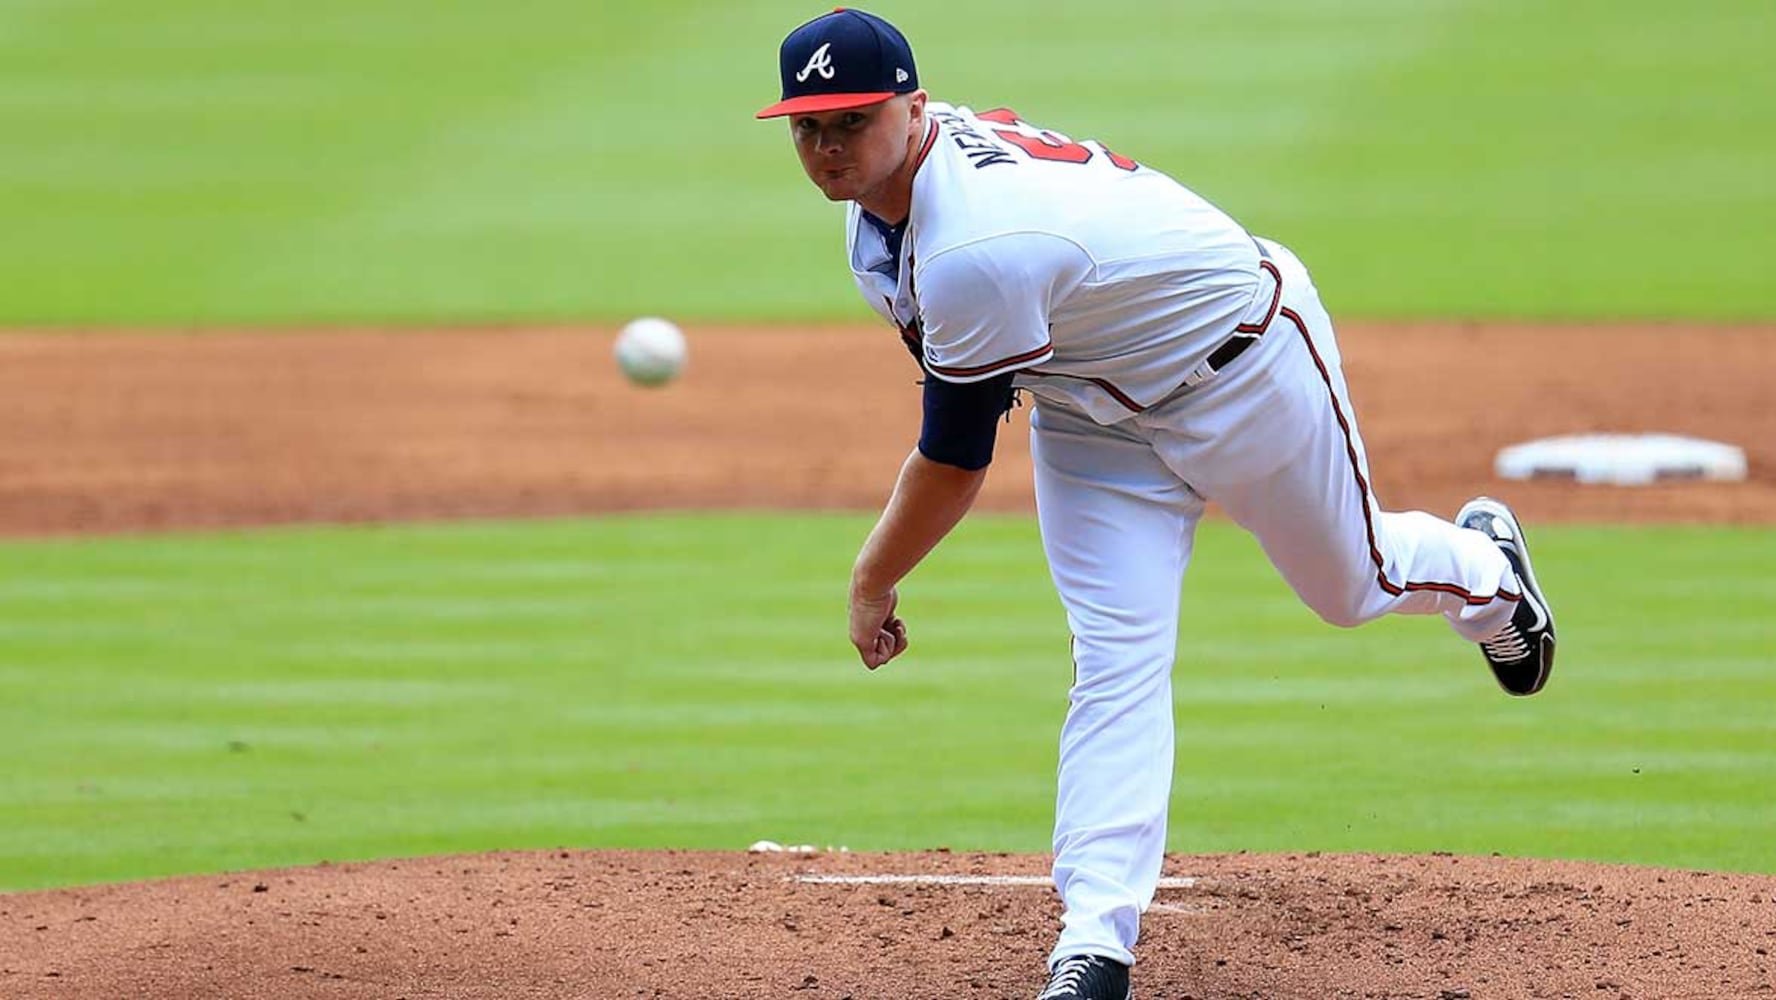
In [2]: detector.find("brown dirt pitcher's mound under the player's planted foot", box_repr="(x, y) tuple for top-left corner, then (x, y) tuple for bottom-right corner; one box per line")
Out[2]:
(0, 851), (1776, 1000)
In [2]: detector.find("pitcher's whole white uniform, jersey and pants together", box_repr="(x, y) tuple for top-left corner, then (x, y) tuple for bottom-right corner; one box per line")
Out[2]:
(847, 101), (1520, 963)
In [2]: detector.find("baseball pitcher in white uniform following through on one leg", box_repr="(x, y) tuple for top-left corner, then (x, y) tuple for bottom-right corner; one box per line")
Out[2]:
(758, 9), (1554, 1000)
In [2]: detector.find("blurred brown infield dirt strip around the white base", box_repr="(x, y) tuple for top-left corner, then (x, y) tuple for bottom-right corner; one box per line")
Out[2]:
(0, 325), (1776, 535)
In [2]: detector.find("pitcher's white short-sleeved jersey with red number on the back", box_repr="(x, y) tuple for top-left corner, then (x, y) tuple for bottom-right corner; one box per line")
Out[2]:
(847, 101), (1275, 423)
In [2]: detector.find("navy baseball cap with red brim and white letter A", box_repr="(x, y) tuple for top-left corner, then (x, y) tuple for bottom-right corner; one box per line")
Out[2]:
(757, 7), (918, 117)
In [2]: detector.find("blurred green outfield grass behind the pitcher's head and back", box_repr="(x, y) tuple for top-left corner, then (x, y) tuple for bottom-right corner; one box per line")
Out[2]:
(0, 0), (1776, 325)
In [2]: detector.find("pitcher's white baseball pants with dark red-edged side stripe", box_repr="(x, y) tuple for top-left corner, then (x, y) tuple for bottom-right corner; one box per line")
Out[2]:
(1030, 242), (1517, 963)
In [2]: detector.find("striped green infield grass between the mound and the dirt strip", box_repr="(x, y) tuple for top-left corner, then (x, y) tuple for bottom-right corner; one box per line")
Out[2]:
(0, 515), (1776, 888)
